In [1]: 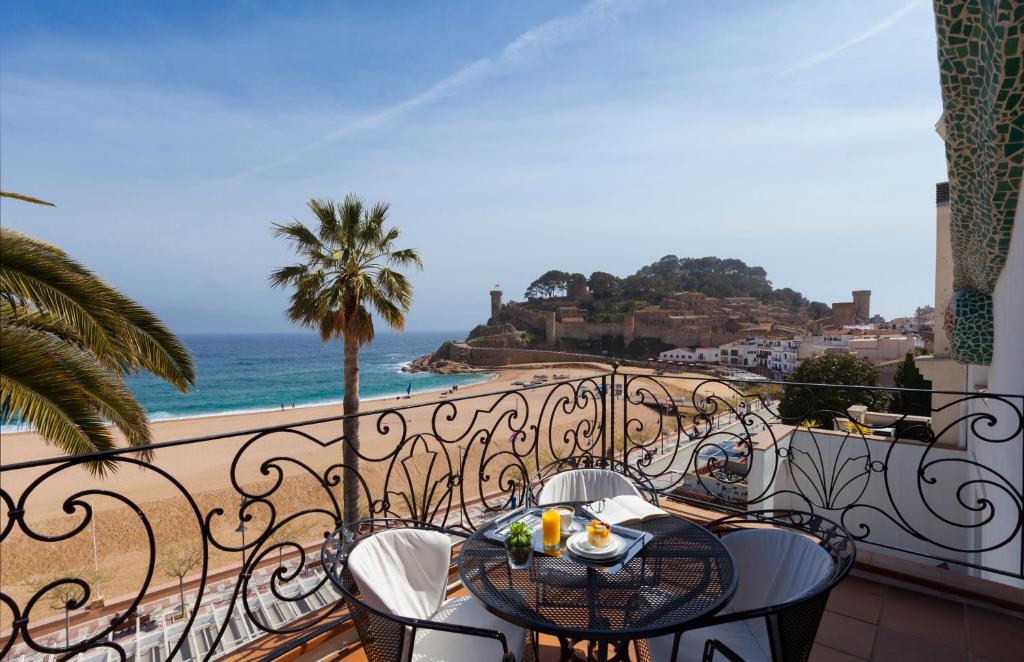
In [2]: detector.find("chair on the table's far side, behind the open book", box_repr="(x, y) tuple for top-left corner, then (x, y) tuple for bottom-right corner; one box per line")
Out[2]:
(530, 456), (657, 505)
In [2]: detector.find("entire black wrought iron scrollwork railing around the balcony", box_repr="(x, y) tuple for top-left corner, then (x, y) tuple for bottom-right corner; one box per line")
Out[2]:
(0, 370), (1024, 660)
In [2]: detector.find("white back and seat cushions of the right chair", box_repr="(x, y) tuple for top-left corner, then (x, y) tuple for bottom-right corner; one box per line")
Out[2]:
(647, 529), (834, 662)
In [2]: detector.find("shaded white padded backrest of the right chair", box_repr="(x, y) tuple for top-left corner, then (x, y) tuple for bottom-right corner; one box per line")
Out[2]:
(722, 529), (835, 612)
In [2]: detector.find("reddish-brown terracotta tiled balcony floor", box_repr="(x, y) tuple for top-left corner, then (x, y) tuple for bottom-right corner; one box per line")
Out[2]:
(343, 576), (1024, 662)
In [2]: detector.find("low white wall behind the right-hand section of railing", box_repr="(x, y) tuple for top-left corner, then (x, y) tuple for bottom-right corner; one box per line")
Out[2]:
(748, 428), (1019, 581)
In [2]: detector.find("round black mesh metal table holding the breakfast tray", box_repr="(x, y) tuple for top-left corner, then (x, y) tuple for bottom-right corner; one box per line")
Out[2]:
(459, 515), (736, 660)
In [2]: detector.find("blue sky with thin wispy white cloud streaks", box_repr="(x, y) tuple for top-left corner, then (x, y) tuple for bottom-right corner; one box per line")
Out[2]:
(0, 0), (946, 333)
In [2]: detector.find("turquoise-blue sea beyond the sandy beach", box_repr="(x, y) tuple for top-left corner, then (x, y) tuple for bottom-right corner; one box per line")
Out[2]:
(115, 332), (487, 420)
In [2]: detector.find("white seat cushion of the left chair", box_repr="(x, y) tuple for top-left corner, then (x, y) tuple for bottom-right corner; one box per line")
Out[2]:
(412, 595), (525, 662)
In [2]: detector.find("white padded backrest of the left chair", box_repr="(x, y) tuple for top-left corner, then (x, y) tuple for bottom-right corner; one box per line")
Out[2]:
(348, 529), (452, 619)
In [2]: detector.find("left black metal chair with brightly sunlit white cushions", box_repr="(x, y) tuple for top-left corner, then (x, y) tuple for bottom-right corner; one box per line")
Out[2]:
(322, 519), (534, 662)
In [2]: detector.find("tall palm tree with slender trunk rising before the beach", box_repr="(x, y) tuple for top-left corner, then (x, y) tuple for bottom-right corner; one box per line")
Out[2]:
(270, 194), (423, 522)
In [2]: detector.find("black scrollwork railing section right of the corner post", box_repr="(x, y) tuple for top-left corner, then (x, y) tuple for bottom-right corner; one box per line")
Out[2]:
(615, 374), (1024, 578)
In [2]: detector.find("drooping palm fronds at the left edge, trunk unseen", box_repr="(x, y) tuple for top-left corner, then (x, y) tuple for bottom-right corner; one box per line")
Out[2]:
(0, 221), (196, 474)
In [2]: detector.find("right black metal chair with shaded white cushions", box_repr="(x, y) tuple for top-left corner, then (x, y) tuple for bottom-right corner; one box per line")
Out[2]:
(647, 510), (855, 662)
